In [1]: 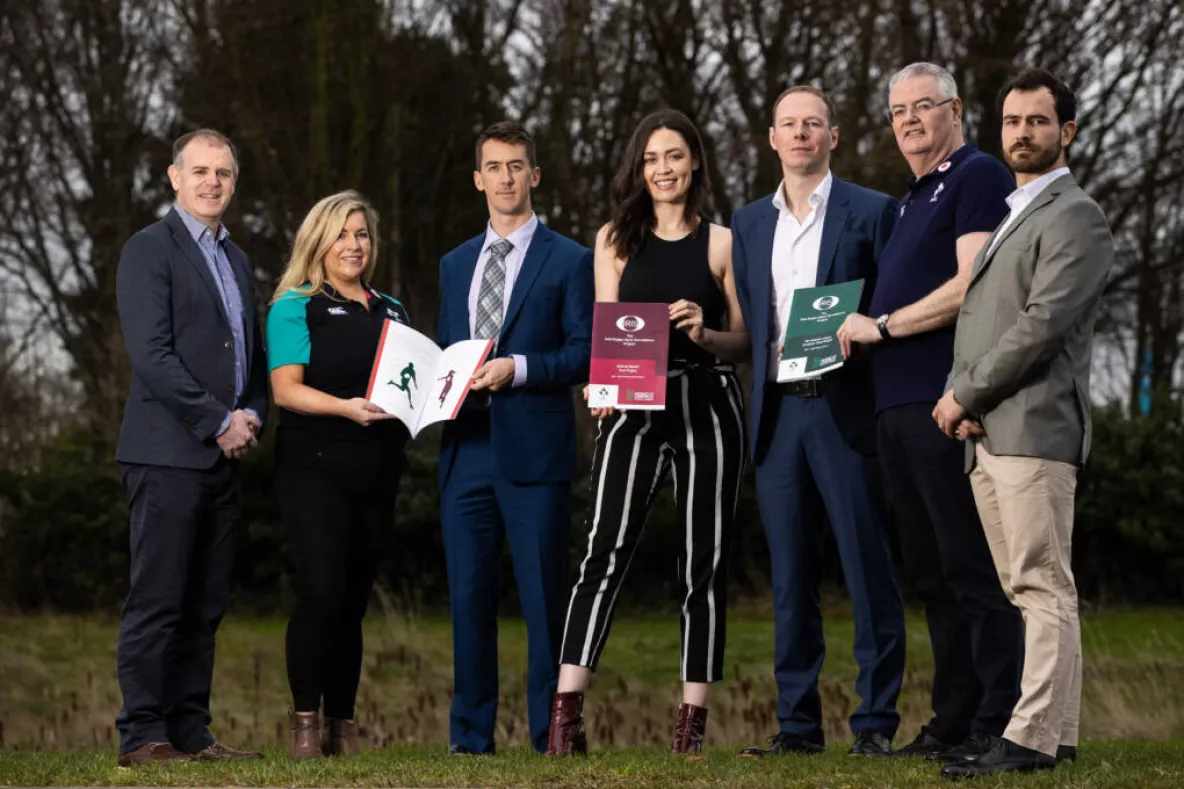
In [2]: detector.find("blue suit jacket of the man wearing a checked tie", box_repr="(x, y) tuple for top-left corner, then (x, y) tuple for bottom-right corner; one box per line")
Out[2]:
(437, 217), (596, 488)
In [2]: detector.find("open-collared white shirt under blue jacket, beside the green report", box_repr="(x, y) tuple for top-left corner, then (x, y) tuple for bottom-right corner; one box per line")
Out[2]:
(768, 172), (835, 381)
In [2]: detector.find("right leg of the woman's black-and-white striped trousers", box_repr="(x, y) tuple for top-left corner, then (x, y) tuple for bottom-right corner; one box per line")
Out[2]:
(667, 368), (745, 682)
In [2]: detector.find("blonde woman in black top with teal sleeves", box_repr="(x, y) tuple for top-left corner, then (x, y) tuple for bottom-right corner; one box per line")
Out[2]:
(268, 192), (408, 759)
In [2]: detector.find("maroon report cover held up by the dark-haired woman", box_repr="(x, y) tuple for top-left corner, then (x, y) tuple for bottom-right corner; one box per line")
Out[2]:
(588, 301), (670, 411)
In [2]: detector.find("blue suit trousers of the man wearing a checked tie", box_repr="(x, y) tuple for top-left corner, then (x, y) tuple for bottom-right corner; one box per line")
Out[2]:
(440, 410), (572, 753)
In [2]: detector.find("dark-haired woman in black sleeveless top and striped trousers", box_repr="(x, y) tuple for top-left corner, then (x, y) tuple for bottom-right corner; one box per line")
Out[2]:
(547, 110), (748, 756)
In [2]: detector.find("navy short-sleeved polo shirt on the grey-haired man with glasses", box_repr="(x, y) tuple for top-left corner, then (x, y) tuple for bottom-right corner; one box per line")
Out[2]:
(868, 143), (1016, 413)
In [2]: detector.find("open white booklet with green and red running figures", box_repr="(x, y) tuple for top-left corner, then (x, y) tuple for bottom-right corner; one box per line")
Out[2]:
(366, 320), (494, 437)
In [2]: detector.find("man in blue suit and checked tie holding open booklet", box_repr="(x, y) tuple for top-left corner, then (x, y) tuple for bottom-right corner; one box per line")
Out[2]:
(437, 121), (594, 753)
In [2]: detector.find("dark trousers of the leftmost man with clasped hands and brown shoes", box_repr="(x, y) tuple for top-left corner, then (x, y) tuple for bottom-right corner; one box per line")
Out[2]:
(116, 457), (239, 753)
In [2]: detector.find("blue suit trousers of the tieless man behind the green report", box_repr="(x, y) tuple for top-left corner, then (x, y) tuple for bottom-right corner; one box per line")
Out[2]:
(755, 385), (905, 743)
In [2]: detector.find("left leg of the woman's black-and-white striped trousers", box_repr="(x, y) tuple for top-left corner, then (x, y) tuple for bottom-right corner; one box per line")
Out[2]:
(560, 411), (668, 671)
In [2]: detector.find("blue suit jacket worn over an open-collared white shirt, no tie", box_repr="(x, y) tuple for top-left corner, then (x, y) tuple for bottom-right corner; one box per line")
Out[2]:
(732, 178), (896, 463)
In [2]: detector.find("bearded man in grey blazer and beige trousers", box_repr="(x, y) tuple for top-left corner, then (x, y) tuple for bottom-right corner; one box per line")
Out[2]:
(933, 69), (1114, 778)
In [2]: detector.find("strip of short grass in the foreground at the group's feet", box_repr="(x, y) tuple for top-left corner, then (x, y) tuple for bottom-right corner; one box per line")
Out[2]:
(0, 742), (1184, 789)
